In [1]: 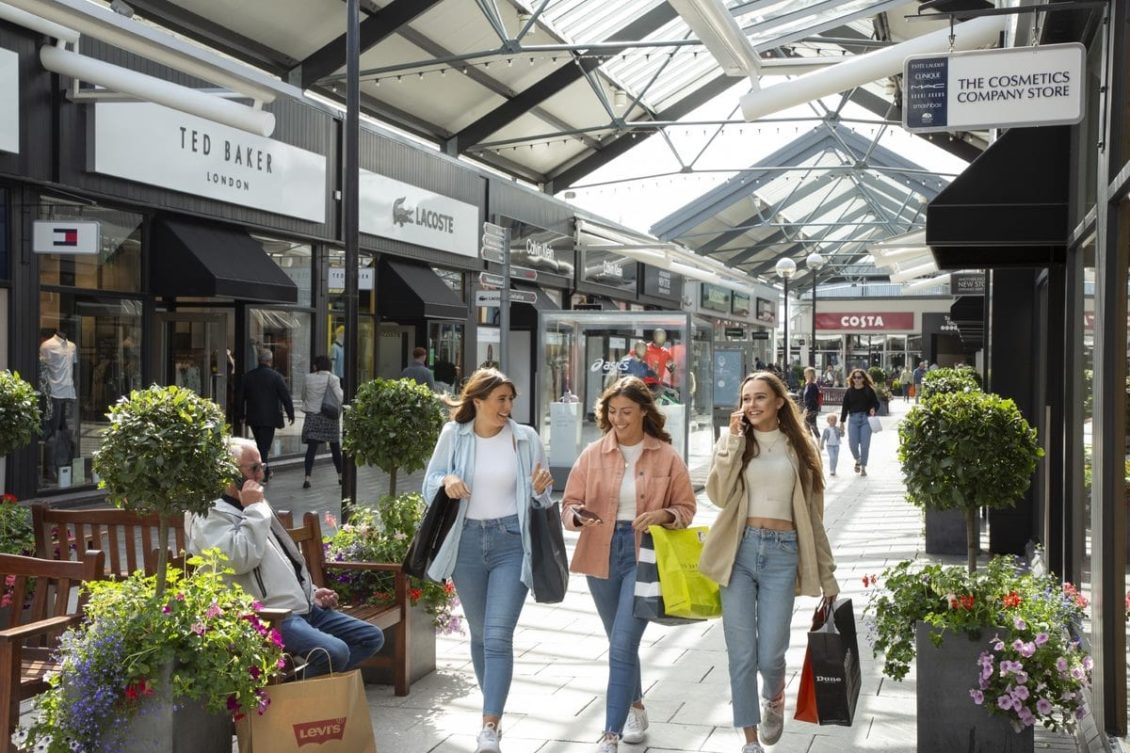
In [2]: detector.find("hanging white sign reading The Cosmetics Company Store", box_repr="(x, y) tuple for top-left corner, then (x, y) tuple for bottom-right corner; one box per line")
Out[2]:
(903, 43), (1087, 132)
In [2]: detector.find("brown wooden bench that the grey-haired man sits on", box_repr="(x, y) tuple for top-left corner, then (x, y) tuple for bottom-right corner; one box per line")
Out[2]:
(32, 504), (411, 695)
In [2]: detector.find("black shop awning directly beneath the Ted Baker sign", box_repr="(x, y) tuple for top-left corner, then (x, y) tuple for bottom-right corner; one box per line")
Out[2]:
(149, 217), (298, 303)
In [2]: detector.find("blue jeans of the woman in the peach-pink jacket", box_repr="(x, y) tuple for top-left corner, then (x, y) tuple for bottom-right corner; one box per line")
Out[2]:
(588, 521), (647, 735)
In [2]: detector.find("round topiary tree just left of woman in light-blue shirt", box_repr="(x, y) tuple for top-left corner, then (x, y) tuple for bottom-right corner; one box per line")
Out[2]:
(341, 379), (444, 496)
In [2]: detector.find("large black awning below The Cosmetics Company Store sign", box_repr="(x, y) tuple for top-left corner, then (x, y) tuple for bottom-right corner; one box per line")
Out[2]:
(925, 126), (1071, 269)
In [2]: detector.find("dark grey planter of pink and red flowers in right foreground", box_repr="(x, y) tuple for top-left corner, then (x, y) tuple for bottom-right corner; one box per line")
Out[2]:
(863, 556), (1093, 753)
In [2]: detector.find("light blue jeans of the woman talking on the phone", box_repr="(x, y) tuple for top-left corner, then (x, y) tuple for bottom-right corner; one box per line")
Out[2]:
(722, 527), (797, 727)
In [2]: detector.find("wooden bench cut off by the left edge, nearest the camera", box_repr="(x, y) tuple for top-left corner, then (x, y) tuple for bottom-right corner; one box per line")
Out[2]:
(0, 551), (105, 753)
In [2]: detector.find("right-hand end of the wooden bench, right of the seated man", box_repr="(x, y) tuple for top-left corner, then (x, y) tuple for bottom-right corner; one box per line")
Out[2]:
(279, 512), (411, 695)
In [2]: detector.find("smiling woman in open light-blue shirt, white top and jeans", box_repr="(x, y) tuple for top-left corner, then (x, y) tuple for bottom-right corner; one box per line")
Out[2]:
(424, 369), (553, 753)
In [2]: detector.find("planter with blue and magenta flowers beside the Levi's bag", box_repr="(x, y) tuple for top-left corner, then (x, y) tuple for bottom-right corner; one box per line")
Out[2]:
(23, 549), (283, 753)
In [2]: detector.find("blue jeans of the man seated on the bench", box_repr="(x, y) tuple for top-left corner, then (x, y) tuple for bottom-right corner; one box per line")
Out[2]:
(279, 606), (384, 677)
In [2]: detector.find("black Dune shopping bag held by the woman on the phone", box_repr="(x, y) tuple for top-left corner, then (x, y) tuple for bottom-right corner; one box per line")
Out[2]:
(808, 599), (861, 727)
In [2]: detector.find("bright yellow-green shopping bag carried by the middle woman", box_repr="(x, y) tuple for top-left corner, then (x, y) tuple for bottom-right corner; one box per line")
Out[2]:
(647, 526), (722, 620)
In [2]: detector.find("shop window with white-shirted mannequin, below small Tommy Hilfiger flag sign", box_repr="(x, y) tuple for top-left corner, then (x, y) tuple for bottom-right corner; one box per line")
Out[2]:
(37, 291), (142, 488)
